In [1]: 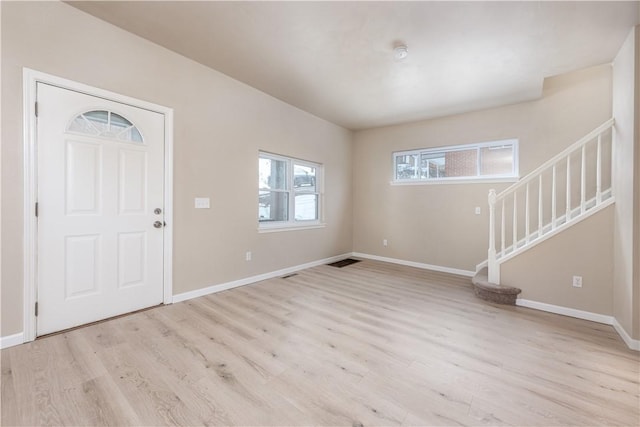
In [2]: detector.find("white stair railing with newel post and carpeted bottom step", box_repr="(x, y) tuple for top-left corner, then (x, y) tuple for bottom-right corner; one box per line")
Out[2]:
(472, 118), (615, 304)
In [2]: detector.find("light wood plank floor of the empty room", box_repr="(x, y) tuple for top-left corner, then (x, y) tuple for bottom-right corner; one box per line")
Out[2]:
(1, 261), (640, 426)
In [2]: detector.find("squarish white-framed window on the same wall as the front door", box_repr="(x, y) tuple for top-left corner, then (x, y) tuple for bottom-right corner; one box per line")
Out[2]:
(258, 152), (322, 228)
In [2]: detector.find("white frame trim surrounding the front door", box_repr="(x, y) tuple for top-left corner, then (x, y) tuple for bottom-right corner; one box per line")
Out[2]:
(22, 68), (173, 342)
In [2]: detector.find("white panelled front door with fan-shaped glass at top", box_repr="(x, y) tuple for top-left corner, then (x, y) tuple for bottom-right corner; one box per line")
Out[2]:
(36, 83), (165, 335)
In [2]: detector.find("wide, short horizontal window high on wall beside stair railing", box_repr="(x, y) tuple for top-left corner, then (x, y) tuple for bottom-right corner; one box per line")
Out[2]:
(393, 139), (518, 183)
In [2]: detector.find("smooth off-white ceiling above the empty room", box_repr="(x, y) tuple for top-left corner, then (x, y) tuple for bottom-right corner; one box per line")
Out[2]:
(69, 1), (640, 129)
